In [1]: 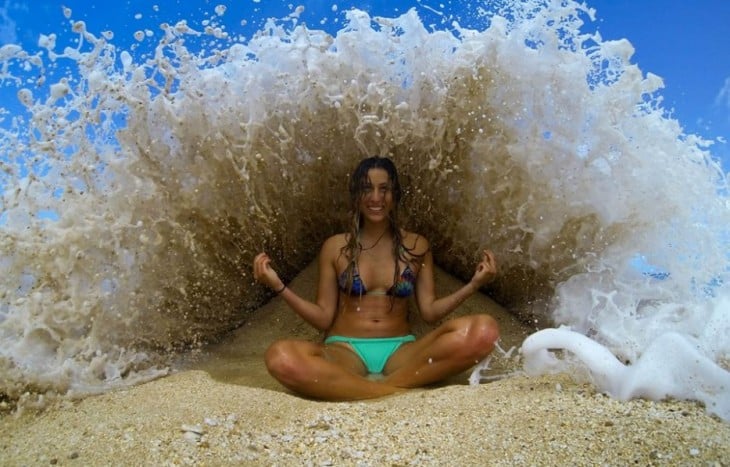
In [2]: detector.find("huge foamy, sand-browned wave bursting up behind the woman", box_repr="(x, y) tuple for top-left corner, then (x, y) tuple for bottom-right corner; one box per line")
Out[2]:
(0, 1), (730, 420)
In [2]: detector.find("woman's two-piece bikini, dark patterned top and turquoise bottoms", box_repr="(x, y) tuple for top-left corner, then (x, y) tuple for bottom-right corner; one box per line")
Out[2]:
(324, 265), (416, 373)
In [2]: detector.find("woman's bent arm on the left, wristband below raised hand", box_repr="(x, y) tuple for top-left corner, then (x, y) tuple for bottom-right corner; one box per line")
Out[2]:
(253, 237), (339, 331)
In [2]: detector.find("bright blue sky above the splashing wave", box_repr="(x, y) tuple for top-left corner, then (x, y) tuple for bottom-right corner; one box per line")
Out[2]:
(0, 0), (730, 172)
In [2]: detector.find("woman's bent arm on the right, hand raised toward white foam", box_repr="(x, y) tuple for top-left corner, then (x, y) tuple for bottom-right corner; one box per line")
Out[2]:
(416, 250), (497, 323)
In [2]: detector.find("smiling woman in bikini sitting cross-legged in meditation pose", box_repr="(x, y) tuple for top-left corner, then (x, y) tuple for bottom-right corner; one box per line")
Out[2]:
(254, 156), (499, 400)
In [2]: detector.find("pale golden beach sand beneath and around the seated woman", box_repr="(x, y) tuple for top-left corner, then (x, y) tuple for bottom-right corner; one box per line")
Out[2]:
(0, 266), (730, 466)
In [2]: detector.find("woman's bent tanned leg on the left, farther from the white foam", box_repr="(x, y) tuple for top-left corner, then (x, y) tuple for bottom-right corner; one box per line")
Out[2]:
(265, 340), (403, 400)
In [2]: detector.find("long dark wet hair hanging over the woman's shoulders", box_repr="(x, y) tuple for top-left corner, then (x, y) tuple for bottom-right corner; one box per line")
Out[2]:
(342, 156), (410, 298)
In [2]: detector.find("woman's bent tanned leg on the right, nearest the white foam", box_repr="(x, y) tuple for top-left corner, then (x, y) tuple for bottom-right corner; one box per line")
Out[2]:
(383, 315), (499, 388)
